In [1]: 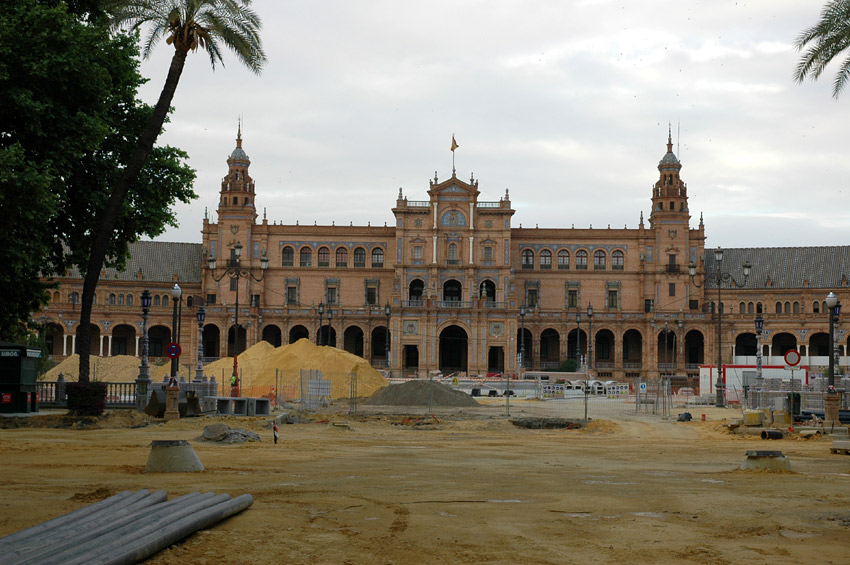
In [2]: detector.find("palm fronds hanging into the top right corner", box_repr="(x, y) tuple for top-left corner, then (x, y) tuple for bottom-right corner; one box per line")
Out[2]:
(794, 0), (850, 99)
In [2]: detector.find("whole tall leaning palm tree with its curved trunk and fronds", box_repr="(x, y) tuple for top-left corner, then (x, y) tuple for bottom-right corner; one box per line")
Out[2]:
(78, 0), (266, 382)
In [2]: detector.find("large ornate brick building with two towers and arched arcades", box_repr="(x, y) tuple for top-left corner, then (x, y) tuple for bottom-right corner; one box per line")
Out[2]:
(39, 126), (850, 388)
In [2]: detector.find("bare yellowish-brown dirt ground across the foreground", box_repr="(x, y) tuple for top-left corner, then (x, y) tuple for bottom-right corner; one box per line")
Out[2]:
(0, 400), (850, 565)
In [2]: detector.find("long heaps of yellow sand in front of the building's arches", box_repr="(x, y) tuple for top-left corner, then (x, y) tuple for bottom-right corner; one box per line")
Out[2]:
(43, 338), (388, 398)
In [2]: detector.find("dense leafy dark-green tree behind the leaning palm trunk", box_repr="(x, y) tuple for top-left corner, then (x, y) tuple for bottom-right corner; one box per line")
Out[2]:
(0, 0), (194, 342)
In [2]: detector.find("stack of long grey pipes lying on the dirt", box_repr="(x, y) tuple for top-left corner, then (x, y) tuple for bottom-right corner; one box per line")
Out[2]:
(0, 490), (254, 565)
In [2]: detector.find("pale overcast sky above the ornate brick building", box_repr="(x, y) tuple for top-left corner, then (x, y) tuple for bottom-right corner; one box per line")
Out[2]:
(141, 0), (850, 247)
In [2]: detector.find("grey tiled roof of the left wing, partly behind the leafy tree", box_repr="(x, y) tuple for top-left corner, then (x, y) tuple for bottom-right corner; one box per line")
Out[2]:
(68, 241), (204, 283)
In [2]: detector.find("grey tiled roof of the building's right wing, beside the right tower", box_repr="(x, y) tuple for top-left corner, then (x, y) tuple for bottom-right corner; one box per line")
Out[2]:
(705, 245), (850, 289)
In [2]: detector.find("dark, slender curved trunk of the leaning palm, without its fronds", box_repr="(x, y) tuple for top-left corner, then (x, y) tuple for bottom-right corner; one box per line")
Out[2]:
(77, 49), (186, 382)
